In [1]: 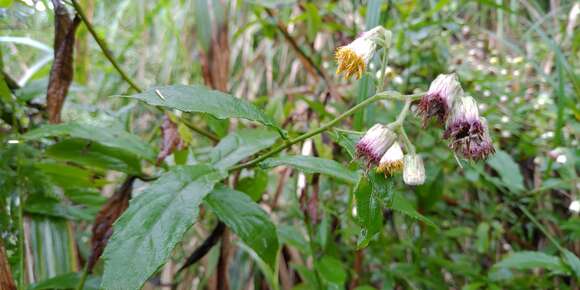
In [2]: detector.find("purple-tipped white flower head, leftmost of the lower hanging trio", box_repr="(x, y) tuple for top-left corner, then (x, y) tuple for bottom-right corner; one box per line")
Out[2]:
(356, 124), (397, 164)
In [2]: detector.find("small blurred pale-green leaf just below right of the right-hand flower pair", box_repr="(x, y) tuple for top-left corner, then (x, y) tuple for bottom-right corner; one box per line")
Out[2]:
(487, 150), (525, 193)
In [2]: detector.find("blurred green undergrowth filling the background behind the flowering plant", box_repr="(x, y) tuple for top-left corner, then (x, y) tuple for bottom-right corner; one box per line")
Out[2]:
(0, 0), (580, 290)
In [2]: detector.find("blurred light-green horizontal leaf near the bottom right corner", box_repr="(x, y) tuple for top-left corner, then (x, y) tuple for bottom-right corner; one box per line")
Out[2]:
(494, 251), (569, 273)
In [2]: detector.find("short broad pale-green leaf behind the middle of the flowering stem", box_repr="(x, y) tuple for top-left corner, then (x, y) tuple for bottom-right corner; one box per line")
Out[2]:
(210, 129), (278, 169)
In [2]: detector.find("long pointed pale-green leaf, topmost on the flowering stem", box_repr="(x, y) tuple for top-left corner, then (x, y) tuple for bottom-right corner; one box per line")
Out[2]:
(124, 85), (279, 128)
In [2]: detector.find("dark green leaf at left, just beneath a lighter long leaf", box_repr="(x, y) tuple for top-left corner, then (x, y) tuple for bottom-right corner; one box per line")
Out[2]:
(46, 139), (141, 175)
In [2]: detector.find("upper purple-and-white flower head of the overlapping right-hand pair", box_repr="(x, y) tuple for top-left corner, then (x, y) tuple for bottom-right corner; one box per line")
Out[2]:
(418, 73), (463, 125)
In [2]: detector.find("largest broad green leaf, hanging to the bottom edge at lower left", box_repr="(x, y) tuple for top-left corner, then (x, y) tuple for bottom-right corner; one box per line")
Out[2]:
(101, 164), (223, 290)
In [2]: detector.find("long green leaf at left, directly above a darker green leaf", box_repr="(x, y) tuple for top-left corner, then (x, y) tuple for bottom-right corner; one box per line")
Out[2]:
(24, 122), (157, 161)
